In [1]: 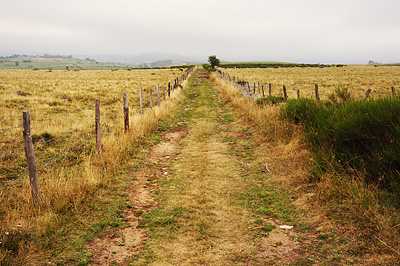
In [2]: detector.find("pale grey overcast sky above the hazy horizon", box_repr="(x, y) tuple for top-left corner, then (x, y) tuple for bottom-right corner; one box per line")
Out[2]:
(0, 0), (400, 63)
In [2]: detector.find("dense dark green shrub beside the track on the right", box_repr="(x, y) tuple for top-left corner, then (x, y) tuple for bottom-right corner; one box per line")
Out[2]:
(282, 98), (400, 200)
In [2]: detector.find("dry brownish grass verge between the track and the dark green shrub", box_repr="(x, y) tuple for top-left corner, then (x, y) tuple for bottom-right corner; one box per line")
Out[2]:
(211, 72), (400, 265)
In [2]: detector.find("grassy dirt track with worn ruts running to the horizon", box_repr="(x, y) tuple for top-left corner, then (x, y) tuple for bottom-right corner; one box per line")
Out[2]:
(89, 70), (328, 265)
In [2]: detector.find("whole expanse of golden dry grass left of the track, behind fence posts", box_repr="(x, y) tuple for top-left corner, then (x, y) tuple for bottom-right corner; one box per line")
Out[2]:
(0, 69), (189, 265)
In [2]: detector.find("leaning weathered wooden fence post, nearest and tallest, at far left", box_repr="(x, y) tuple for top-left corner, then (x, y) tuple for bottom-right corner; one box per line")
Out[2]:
(22, 111), (40, 204)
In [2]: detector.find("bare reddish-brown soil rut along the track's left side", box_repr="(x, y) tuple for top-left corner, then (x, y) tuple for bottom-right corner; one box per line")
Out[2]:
(88, 126), (187, 265)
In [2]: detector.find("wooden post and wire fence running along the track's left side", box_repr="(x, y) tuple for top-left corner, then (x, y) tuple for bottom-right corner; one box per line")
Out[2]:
(0, 67), (194, 202)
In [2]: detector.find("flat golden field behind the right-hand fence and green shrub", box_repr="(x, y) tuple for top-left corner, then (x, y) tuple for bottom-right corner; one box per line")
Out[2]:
(221, 65), (400, 99)
